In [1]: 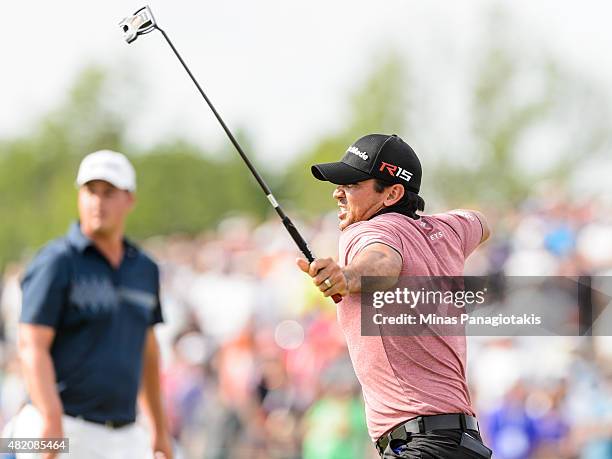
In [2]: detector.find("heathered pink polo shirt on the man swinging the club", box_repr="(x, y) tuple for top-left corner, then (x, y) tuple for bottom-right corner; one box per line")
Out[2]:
(338, 210), (483, 440)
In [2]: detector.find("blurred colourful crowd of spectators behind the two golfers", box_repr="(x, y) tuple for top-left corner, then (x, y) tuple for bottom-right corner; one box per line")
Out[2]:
(0, 192), (612, 459)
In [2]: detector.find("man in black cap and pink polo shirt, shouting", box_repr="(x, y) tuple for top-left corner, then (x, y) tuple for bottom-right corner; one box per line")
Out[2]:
(298, 134), (491, 459)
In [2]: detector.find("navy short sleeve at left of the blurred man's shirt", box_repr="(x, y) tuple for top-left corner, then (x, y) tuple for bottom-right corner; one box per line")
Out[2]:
(19, 247), (70, 328)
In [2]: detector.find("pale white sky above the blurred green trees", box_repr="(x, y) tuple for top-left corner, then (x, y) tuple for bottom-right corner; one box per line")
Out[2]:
(0, 0), (612, 172)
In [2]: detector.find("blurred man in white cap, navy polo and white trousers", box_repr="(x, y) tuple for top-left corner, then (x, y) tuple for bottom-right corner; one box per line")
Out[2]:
(12, 150), (172, 459)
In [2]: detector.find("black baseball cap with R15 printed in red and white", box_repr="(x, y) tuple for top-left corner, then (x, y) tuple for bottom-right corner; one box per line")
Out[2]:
(311, 134), (422, 194)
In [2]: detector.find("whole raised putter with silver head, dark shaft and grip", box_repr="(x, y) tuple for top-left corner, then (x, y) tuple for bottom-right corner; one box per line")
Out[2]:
(119, 6), (342, 303)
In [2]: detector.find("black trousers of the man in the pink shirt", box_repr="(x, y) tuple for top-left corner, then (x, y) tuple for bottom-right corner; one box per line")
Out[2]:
(381, 429), (491, 459)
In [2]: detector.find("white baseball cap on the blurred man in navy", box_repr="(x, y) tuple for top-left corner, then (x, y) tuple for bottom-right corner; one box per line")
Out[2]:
(77, 150), (136, 192)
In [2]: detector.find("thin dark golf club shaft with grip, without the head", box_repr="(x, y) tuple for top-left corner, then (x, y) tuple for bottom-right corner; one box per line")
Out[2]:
(155, 25), (342, 303)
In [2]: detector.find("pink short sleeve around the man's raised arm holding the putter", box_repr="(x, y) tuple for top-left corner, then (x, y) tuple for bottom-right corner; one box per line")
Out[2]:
(340, 220), (403, 266)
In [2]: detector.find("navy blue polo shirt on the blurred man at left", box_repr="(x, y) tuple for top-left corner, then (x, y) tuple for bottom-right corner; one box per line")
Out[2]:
(20, 223), (162, 422)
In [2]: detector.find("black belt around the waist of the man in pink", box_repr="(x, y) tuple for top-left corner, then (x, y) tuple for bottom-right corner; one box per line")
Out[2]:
(376, 414), (480, 454)
